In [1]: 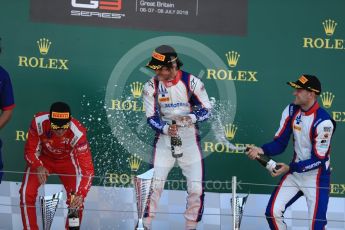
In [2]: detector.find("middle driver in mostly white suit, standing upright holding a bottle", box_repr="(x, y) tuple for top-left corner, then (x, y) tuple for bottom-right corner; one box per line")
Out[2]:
(143, 45), (211, 229)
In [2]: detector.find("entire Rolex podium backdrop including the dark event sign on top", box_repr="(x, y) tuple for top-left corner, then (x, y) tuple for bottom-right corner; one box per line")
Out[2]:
(0, 0), (345, 197)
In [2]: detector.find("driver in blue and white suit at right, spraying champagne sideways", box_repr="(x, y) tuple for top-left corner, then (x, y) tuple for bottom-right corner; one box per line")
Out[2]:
(248, 74), (335, 230)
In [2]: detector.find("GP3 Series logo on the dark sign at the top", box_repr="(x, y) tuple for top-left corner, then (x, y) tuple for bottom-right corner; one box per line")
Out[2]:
(71, 0), (125, 19)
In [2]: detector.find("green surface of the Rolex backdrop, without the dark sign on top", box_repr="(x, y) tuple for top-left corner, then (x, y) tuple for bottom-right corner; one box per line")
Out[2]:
(0, 0), (345, 196)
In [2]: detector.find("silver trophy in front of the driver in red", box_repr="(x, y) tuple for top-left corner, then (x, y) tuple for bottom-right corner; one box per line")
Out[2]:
(39, 192), (62, 230)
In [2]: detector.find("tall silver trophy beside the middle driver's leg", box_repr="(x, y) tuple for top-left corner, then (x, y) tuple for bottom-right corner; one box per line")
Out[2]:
(134, 169), (154, 230)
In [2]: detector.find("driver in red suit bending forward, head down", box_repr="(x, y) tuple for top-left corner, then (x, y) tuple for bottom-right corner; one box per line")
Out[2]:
(20, 102), (94, 230)
